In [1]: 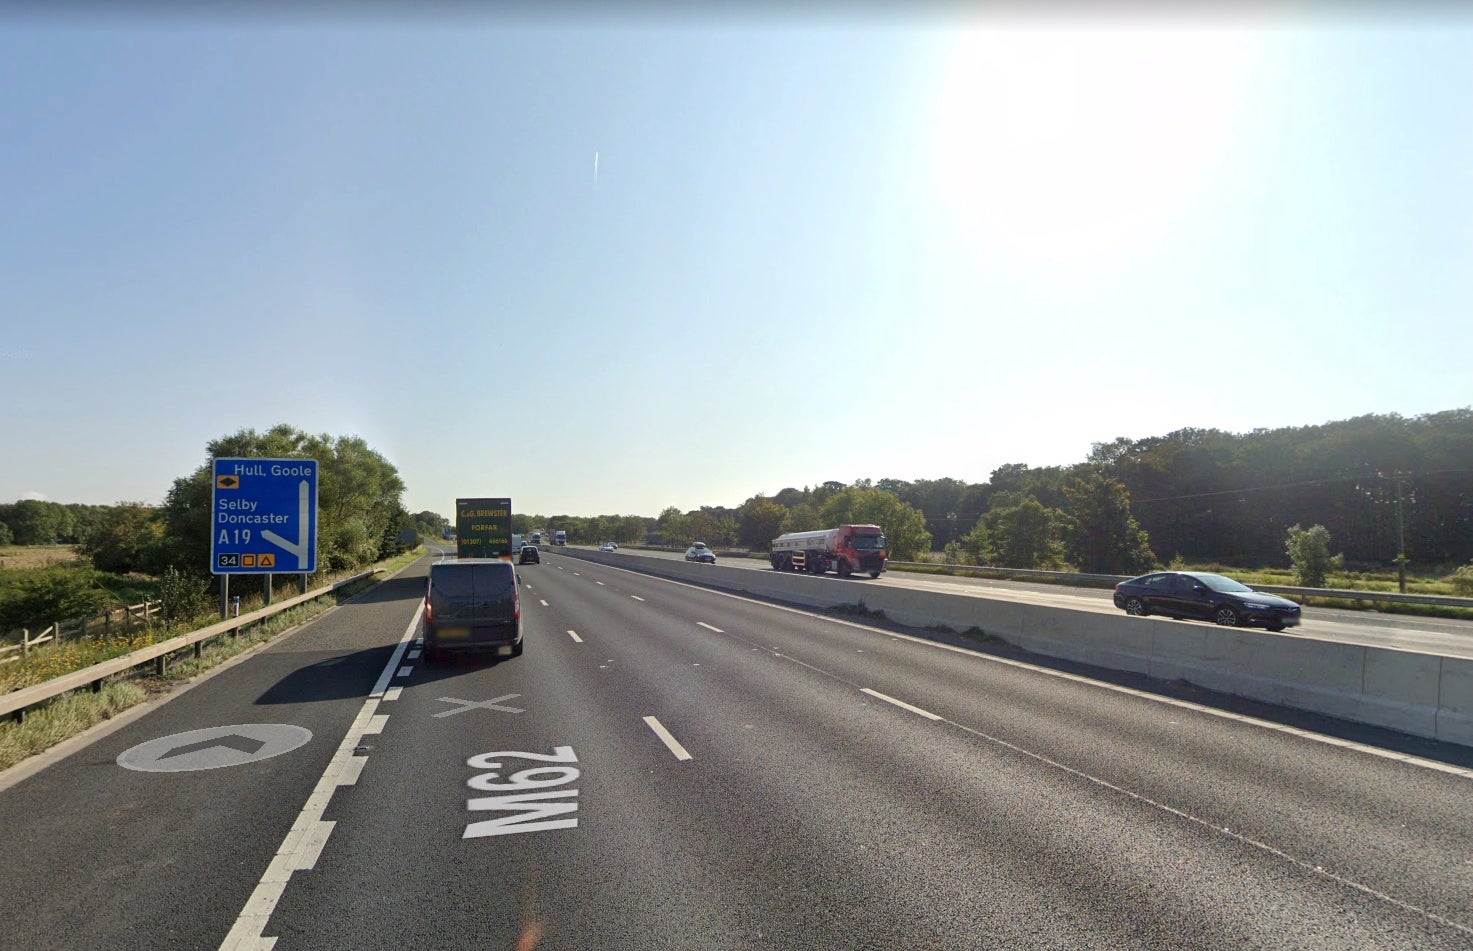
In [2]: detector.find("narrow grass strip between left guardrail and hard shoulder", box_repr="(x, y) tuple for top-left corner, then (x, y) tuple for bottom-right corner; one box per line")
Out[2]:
(0, 552), (423, 770)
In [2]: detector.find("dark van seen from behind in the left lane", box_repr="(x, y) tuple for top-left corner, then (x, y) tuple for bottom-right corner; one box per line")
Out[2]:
(424, 558), (521, 662)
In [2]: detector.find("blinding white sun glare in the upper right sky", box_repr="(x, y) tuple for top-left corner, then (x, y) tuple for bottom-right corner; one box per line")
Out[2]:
(932, 25), (1254, 269)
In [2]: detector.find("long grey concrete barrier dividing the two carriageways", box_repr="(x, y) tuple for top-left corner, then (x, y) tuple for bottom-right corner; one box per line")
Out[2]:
(553, 551), (1473, 746)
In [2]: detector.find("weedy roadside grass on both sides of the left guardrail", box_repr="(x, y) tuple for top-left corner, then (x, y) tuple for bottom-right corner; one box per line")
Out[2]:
(0, 549), (424, 770)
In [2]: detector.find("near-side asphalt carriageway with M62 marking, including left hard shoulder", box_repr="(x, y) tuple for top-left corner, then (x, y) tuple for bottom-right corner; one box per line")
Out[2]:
(0, 551), (1473, 951)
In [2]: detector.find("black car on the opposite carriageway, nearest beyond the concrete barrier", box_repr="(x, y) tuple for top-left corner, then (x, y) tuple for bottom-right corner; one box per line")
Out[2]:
(1115, 571), (1301, 632)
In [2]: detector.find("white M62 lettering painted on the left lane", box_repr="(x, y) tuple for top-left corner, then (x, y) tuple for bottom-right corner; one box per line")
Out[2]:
(461, 746), (577, 839)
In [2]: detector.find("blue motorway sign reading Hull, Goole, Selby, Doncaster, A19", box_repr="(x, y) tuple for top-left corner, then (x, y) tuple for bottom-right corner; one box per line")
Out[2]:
(209, 459), (317, 574)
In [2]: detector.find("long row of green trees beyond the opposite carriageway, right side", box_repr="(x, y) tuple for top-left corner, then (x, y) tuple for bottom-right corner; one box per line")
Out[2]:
(497, 408), (1473, 574)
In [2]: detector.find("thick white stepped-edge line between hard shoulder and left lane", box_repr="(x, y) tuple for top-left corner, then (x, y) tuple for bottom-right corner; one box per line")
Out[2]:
(219, 602), (424, 951)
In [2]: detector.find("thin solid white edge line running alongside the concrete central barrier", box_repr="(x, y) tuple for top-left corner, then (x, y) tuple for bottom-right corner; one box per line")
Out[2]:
(550, 550), (1473, 779)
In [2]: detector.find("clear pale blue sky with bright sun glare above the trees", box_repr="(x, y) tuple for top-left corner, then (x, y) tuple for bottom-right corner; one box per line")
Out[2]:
(0, 3), (1473, 515)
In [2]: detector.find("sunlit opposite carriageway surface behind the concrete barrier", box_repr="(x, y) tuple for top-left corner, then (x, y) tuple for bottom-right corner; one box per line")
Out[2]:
(619, 549), (1473, 658)
